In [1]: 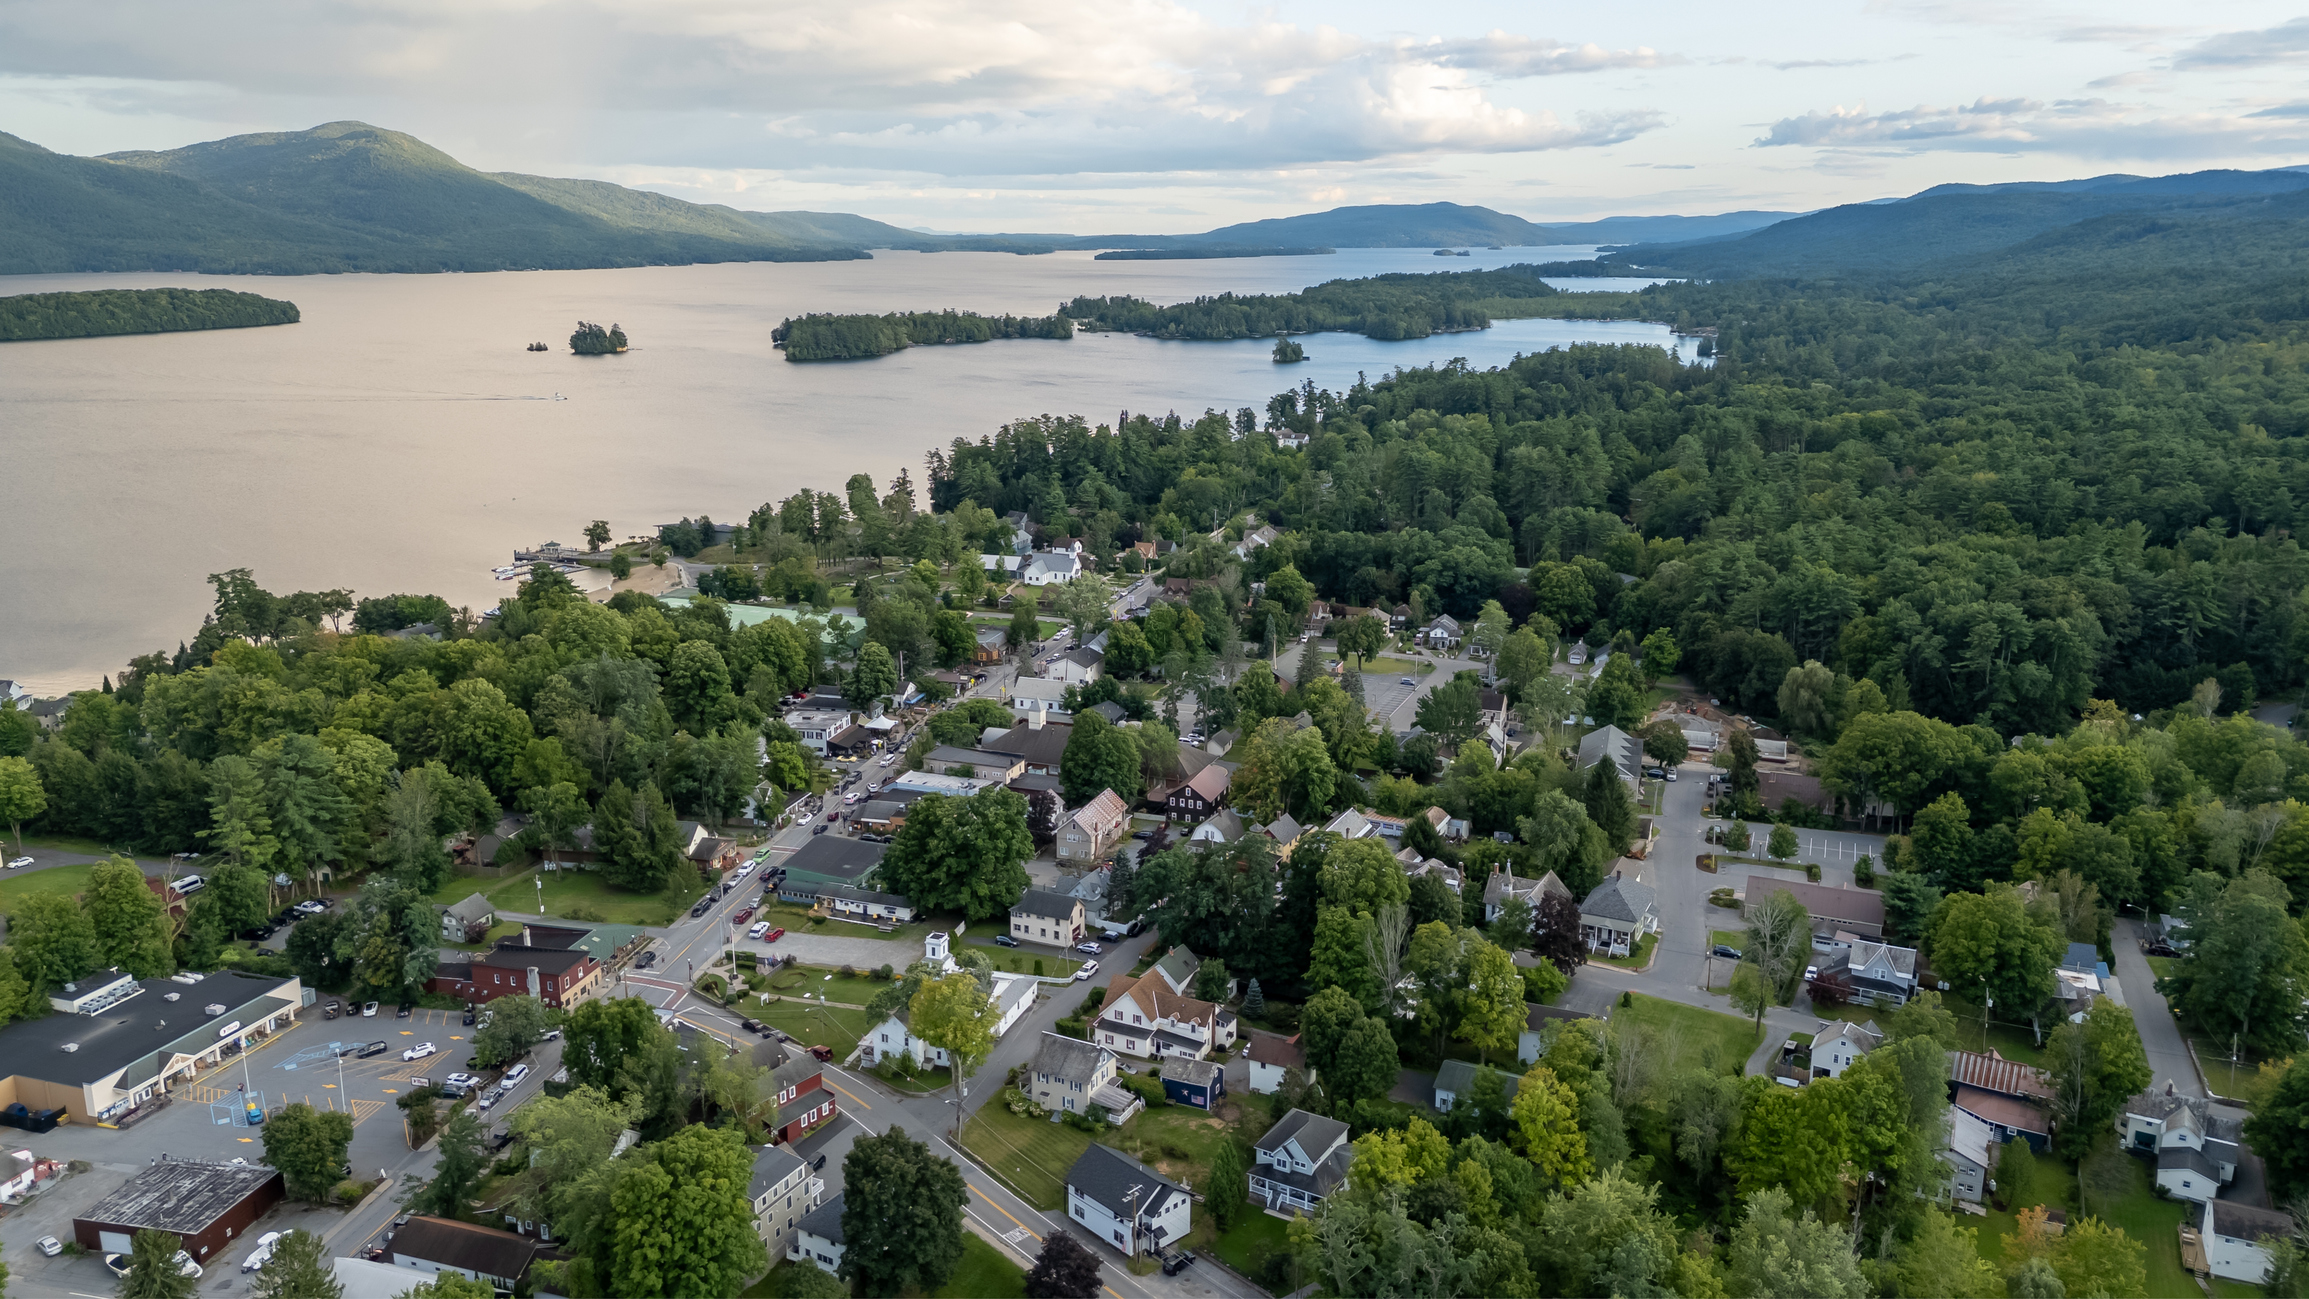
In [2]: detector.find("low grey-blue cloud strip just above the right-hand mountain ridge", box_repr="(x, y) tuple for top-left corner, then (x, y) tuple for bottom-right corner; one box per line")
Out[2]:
(1755, 97), (2309, 162)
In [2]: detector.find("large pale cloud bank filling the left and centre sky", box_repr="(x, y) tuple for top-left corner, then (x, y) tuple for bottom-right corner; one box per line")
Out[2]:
(0, 0), (1674, 175)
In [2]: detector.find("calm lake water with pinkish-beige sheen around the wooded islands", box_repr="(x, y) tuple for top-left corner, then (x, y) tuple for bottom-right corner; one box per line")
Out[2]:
(0, 247), (1690, 694)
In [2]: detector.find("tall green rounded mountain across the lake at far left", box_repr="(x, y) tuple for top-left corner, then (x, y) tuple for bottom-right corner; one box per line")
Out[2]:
(0, 122), (868, 275)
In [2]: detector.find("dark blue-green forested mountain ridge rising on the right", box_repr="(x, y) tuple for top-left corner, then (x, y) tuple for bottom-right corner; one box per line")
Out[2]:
(1609, 171), (2309, 279)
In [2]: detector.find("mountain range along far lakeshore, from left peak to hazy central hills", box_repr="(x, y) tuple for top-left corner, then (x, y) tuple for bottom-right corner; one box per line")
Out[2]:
(0, 122), (1785, 275)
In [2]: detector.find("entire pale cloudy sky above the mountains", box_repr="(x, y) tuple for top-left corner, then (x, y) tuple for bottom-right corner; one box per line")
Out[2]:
(0, 0), (2309, 233)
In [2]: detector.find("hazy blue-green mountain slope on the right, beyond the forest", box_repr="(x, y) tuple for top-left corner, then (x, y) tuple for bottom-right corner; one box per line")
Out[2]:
(1605, 168), (2309, 279)
